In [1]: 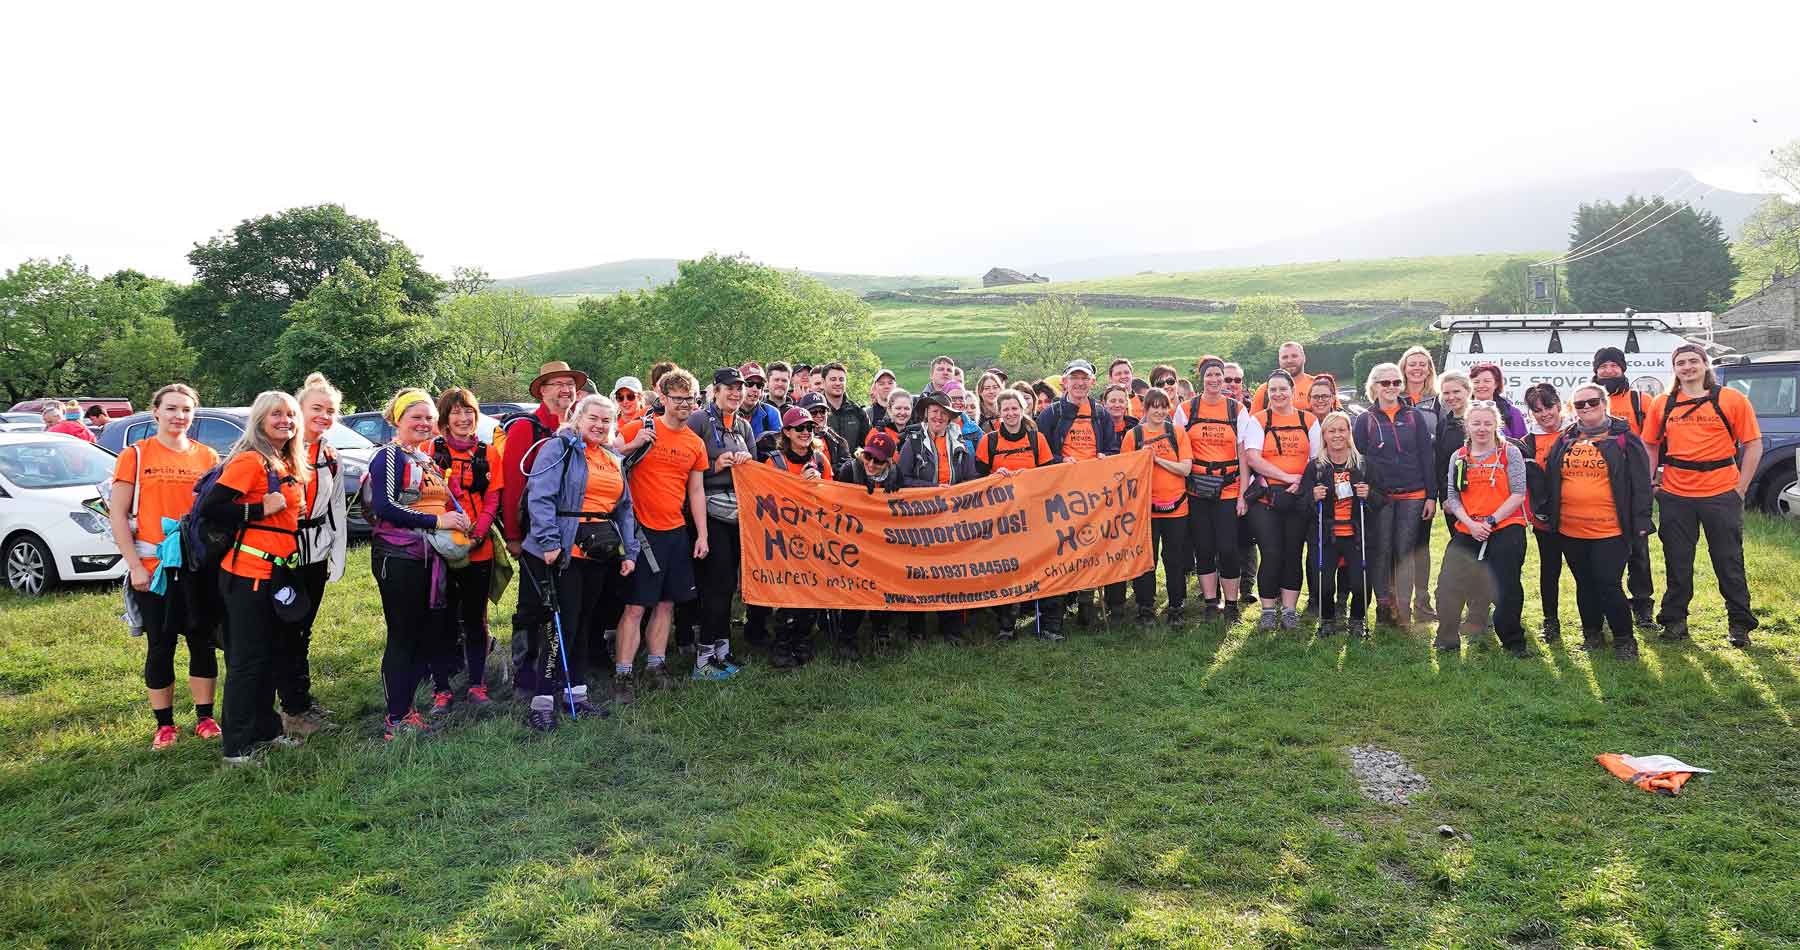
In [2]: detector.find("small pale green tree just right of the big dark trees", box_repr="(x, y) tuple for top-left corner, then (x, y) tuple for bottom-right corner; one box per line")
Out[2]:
(439, 290), (571, 399)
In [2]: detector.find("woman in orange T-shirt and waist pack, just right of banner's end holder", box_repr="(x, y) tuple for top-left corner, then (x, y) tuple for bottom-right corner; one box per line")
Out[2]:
(1179, 356), (1244, 621)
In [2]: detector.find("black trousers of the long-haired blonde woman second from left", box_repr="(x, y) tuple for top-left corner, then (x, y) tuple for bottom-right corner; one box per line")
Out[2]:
(220, 570), (299, 756)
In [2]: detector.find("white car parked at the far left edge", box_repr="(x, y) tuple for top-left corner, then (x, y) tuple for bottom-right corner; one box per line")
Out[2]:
(0, 432), (126, 594)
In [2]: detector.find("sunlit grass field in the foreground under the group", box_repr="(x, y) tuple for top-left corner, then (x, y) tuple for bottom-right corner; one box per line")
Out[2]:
(0, 516), (1800, 948)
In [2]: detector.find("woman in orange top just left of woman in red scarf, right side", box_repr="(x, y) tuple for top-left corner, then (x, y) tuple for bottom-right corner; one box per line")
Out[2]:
(1433, 399), (1525, 657)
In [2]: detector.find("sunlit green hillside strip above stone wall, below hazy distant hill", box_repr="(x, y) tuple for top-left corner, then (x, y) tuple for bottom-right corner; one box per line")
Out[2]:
(964, 252), (1553, 302)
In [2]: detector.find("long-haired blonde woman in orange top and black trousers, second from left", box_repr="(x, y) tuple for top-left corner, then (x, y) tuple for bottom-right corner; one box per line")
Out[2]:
(198, 392), (311, 765)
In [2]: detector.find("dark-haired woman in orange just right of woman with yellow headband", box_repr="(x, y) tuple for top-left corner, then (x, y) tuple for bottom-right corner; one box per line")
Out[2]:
(432, 387), (504, 716)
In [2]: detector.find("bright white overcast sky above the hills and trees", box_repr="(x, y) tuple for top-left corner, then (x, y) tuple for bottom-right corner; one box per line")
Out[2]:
(0, 0), (1800, 279)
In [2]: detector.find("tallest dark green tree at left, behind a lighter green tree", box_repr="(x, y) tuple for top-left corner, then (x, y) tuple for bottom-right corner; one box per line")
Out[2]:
(171, 205), (443, 401)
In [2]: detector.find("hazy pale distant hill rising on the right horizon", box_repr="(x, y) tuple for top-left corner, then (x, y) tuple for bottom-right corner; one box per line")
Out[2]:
(1028, 169), (1764, 281)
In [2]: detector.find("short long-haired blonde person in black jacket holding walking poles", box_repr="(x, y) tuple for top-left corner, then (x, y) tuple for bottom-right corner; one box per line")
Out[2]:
(1300, 410), (1386, 639)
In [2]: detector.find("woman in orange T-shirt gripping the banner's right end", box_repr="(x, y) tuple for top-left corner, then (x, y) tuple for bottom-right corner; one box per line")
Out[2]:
(1120, 385), (1193, 624)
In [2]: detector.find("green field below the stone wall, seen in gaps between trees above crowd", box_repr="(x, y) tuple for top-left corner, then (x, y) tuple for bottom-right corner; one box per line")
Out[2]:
(871, 300), (1355, 392)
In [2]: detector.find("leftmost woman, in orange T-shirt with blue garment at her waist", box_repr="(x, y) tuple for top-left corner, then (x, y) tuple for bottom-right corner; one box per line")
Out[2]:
(108, 383), (220, 748)
